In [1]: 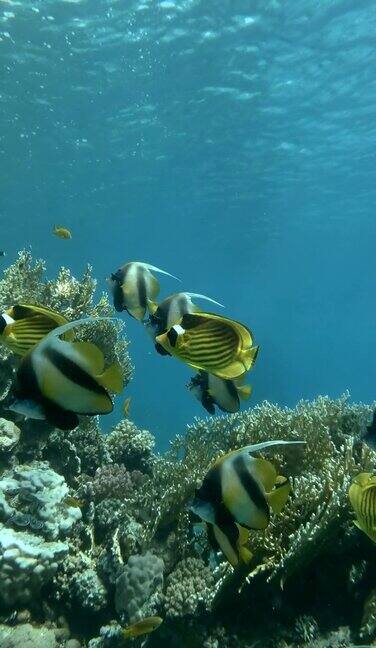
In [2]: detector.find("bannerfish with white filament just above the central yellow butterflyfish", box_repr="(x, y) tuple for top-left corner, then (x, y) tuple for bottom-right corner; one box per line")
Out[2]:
(145, 292), (223, 355)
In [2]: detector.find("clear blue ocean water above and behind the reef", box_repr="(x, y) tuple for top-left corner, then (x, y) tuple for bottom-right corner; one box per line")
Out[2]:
(0, 0), (376, 447)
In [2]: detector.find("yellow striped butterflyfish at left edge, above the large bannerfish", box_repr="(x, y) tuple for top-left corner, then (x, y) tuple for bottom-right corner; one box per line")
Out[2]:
(0, 304), (68, 355)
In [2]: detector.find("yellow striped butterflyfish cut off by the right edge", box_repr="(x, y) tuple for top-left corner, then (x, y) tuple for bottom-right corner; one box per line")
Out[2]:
(349, 473), (376, 542)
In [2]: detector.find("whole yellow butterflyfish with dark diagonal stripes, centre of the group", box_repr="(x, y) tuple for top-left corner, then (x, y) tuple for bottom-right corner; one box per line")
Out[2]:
(155, 313), (258, 380)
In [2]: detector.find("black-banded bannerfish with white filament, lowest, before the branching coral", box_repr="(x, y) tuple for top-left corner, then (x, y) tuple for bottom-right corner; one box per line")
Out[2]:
(191, 441), (305, 530)
